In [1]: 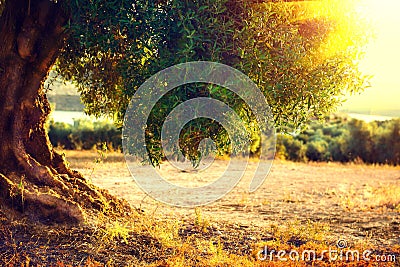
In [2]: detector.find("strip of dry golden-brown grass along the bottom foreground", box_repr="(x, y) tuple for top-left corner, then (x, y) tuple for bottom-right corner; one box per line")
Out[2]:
(0, 209), (400, 267)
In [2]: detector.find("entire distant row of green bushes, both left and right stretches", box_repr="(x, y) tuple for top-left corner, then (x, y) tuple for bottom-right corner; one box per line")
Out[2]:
(48, 116), (400, 165)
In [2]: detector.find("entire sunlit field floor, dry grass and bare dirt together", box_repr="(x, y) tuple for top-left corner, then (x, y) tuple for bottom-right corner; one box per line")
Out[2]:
(0, 151), (400, 266)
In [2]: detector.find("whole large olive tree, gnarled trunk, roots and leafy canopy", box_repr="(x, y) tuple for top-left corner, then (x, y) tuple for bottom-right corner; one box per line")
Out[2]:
(0, 0), (365, 222)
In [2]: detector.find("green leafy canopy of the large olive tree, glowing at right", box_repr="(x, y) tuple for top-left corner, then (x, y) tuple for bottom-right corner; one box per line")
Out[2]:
(50, 0), (369, 163)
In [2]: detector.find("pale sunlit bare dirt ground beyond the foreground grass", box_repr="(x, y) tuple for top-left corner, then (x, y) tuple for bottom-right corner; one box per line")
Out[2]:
(66, 151), (400, 249)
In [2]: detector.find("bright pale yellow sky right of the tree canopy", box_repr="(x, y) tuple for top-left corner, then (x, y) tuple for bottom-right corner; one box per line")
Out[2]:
(341, 0), (400, 116)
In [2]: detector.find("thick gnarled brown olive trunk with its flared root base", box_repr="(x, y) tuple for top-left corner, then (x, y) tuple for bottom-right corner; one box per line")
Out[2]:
(0, 0), (130, 223)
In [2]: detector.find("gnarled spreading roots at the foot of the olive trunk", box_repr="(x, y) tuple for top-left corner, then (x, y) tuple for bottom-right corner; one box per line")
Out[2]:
(0, 165), (133, 224)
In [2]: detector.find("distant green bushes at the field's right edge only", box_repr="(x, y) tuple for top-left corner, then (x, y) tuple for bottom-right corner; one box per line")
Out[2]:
(277, 117), (400, 165)
